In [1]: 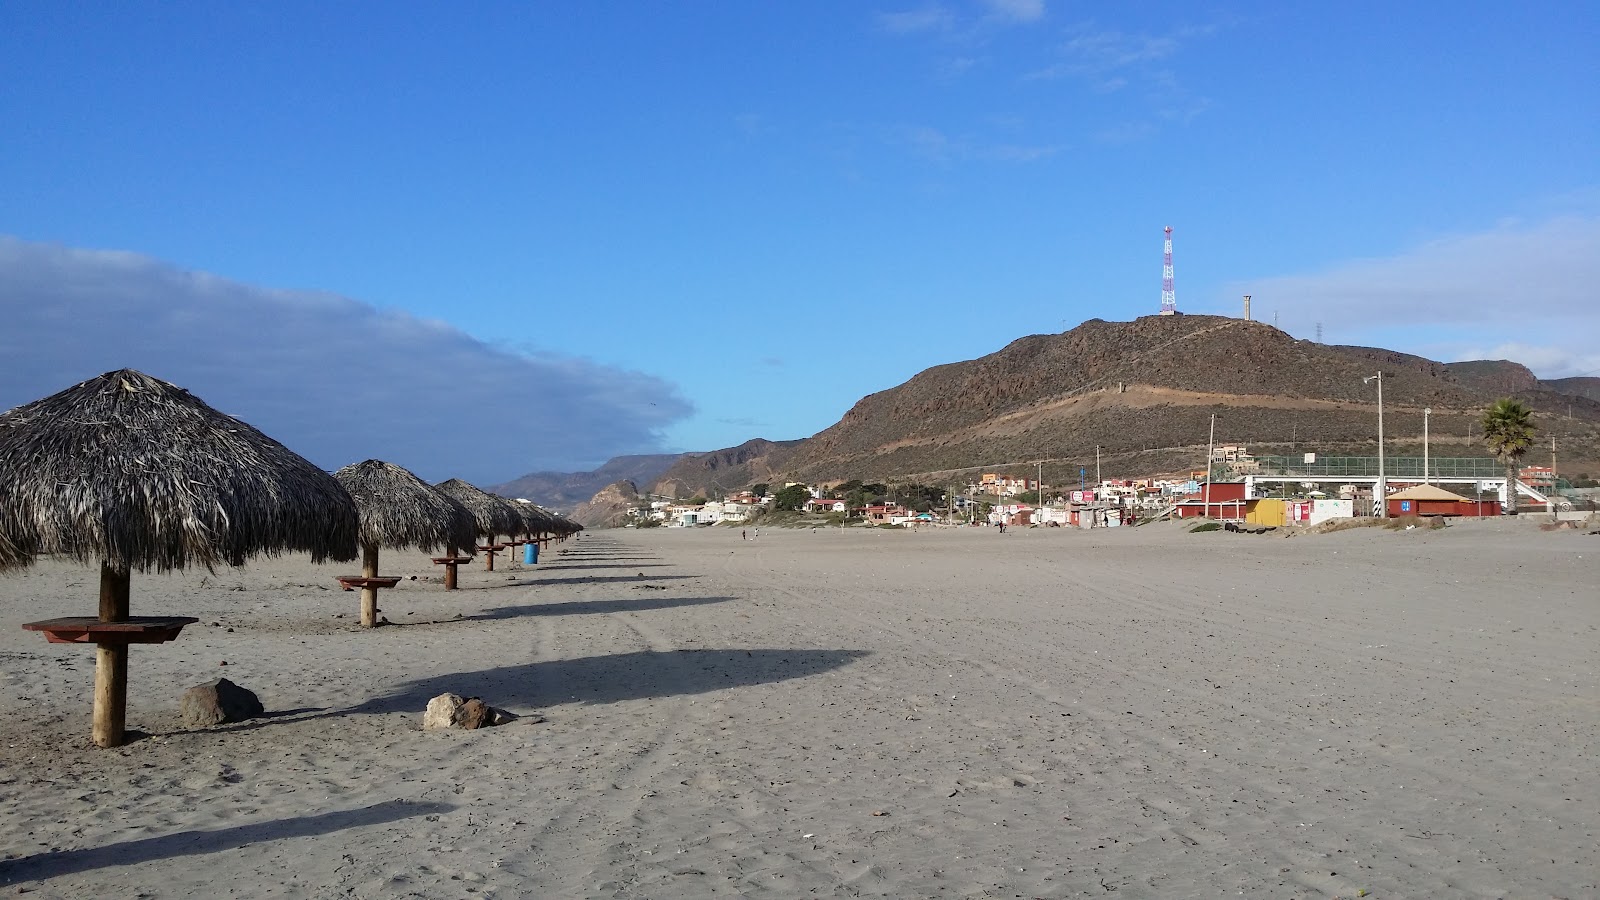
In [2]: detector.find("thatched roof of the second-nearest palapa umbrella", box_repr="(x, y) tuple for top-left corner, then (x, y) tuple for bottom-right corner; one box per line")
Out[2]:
(333, 460), (478, 549)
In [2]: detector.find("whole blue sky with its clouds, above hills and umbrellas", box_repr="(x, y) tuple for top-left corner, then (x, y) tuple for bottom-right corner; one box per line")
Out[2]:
(0, 0), (1600, 484)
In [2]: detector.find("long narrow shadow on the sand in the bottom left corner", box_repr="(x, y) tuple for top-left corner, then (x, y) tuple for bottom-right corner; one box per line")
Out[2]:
(0, 801), (456, 884)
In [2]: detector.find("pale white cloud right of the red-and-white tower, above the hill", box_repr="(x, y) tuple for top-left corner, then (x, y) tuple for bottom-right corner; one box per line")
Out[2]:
(1229, 218), (1600, 378)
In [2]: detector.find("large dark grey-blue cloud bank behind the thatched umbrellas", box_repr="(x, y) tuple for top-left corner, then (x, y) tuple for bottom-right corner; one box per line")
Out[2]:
(0, 237), (691, 484)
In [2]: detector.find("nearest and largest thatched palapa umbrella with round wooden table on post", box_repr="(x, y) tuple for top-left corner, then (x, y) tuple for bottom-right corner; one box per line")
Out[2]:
(0, 368), (357, 746)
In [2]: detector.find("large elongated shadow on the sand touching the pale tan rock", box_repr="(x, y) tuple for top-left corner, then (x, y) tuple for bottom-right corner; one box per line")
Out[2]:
(337, 649), (867, 716)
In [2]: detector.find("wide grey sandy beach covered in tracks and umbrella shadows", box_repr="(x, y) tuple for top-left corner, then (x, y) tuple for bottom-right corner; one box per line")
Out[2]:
(0, 519), (1600, 898)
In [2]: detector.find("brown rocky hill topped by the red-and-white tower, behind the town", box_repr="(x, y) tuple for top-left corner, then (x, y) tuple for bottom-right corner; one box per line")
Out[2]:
(774, 315), (1600, 482)
